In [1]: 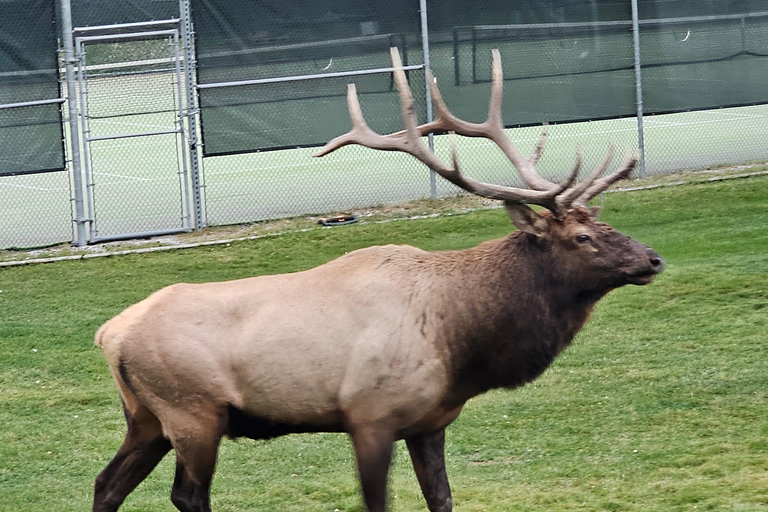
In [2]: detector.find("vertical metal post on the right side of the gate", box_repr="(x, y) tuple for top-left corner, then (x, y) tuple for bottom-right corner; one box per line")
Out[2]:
(179, 0), (205, 229)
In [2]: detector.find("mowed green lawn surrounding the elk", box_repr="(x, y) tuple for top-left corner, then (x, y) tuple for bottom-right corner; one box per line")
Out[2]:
(0, 177), (768, 512)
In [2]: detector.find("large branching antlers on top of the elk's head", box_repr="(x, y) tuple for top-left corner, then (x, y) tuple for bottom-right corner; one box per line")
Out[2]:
(314, 48), (637, 217)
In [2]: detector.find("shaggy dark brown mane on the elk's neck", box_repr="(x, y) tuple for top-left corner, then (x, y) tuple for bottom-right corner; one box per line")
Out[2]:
(422, 231), (607, 402)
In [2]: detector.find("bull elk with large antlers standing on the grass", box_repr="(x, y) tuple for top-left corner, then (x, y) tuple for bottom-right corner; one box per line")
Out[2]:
(93, 49), (664, 512)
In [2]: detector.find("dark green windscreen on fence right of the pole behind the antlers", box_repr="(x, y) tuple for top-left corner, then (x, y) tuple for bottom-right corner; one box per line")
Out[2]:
(429, 0), (768, 125)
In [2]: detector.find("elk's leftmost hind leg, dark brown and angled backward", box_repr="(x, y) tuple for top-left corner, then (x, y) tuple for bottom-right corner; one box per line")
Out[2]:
(93, 396), (171, 512)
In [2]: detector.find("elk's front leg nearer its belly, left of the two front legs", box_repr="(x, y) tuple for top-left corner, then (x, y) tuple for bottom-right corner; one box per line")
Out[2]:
(351, 427), (394, 512)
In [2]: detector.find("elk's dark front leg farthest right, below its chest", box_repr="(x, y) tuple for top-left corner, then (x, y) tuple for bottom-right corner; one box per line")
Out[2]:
(405, 429), (453, 512)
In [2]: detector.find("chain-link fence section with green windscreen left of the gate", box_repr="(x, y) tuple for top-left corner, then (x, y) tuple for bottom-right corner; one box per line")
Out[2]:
(0, 0), (72, 248)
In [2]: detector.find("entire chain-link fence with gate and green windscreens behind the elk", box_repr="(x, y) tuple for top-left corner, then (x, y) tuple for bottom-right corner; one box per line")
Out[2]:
(0, 0), (768, 248)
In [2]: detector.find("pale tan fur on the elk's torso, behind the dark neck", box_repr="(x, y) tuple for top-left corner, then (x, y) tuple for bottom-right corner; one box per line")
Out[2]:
(97, 246), (462, 440)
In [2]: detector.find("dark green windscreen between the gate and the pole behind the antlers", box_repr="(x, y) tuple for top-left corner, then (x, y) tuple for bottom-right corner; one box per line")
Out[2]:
(192, 0), (424, 156)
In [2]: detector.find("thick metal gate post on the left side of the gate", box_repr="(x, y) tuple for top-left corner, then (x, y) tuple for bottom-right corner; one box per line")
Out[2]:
(61, 0), (88, 246)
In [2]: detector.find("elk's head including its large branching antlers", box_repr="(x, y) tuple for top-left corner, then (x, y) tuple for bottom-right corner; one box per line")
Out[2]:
(314, 48), (664, 295)
